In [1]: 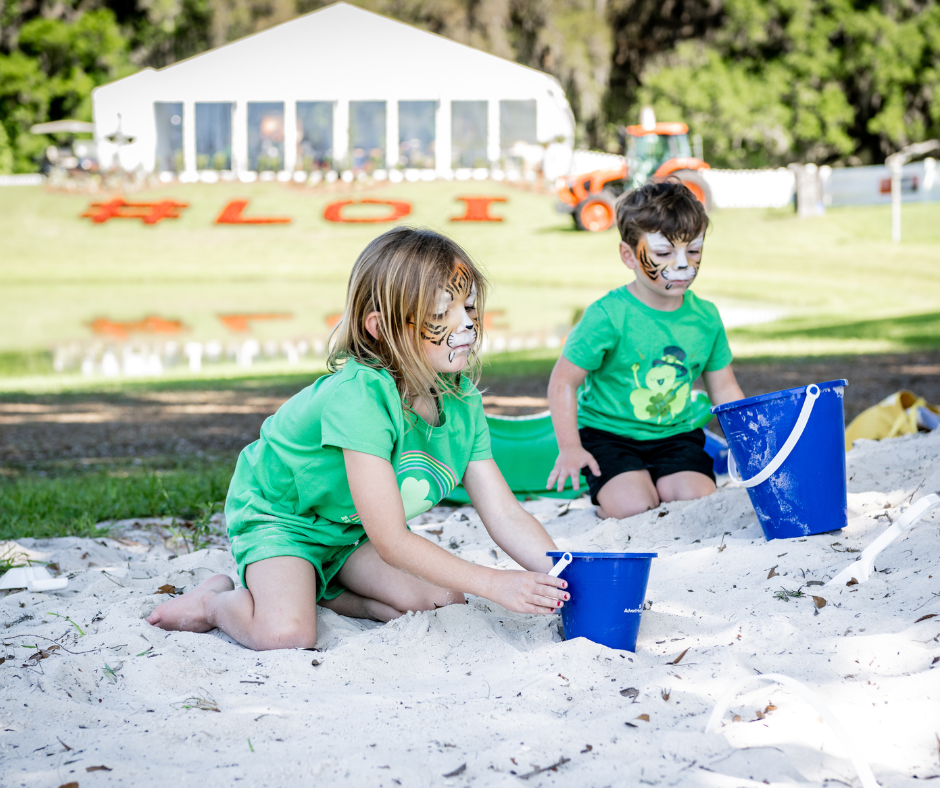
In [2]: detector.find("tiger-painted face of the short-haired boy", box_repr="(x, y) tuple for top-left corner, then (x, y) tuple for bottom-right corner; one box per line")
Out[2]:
(620, 228), (705, 308)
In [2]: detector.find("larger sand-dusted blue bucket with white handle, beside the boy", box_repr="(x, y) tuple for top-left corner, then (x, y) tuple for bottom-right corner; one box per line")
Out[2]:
(712, 380), (848, 539)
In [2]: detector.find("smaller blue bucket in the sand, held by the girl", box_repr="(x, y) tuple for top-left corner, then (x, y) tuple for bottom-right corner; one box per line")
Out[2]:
(548, 550), (657, 651)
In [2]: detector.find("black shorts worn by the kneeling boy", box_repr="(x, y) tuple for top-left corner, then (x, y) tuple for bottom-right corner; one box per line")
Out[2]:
(578, 427), (715, 505)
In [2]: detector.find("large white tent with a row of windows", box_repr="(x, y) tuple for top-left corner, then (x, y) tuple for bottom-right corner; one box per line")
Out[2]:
(93, 3), (574, 177)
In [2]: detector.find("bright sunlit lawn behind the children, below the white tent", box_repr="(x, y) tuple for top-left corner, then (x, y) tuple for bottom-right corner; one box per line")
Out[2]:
(0, 181), (940, 385)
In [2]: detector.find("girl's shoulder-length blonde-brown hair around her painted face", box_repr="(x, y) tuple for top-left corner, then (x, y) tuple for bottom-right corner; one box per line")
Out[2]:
(327, 227), (486, 411)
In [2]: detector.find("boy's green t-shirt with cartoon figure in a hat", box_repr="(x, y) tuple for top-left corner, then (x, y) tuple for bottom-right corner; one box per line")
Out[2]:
(563, 287), (731, 440)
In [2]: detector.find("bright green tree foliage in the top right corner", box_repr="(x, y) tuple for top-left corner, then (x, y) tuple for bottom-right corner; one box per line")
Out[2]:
(638, 0), (940, 167)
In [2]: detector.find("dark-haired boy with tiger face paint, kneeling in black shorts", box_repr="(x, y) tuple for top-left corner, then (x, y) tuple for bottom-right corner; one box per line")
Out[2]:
(546, 181), (744, 519)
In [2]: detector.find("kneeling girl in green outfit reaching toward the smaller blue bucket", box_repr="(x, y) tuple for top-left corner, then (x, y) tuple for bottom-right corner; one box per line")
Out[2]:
(147, 227), (570, 649)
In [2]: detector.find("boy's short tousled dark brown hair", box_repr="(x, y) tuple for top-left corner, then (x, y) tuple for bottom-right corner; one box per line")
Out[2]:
(616, 178), (708, 251)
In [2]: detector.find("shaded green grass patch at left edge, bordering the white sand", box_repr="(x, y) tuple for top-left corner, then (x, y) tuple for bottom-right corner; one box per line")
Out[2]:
(0, 461), (234, 540)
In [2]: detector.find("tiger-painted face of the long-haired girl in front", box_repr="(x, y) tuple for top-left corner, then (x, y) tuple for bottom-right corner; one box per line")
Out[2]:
(421, 264), (480, 372)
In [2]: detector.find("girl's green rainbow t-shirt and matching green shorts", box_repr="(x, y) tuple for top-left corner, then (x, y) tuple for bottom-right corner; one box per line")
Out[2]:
(225, 360), (493, 546)
